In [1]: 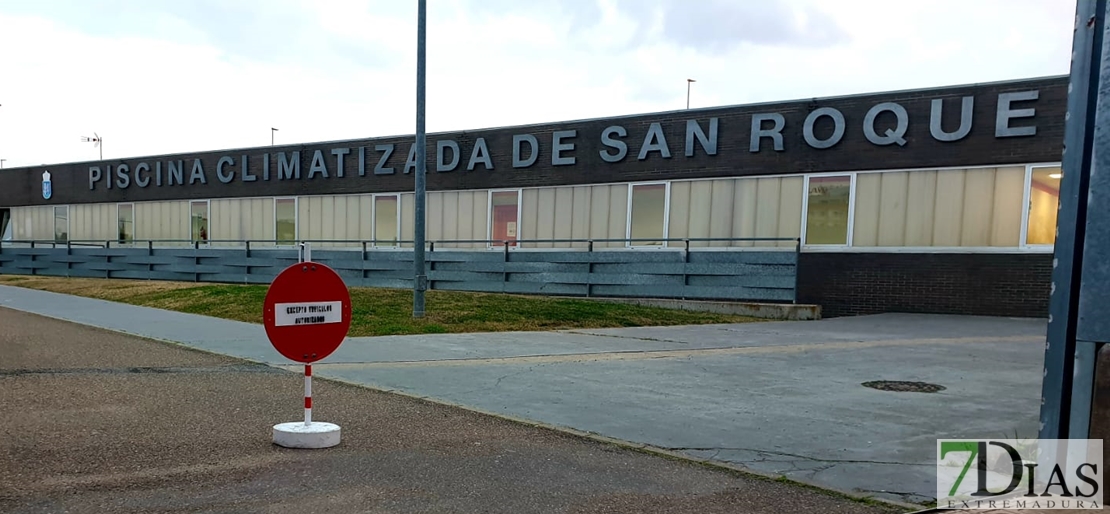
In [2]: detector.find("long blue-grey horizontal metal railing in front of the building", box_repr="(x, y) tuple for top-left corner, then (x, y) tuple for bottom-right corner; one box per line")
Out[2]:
(0, 238), (800, 302)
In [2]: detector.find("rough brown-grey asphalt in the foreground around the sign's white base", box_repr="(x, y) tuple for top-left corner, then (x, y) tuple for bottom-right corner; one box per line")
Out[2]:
(0, 309), (900, 513)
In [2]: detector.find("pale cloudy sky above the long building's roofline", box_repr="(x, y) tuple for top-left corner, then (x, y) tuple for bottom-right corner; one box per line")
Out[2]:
(0, 0), (1076, 168)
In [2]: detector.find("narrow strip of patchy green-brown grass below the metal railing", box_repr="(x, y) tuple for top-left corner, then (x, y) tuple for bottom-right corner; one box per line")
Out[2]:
(0, 275), (760, 336)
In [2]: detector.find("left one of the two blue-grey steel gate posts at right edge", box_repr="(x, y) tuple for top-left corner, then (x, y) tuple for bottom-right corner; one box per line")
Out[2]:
(1038, 0), (1107, 440)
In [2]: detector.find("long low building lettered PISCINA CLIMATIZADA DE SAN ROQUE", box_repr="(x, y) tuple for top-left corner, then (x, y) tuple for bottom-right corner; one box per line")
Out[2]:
(0, 77), (1068, 316)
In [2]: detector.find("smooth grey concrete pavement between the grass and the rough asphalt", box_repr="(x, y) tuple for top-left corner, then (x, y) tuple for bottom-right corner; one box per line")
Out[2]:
(0, 286), (1045, 503)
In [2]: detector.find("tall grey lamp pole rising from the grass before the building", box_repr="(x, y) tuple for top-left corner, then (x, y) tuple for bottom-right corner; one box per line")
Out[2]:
(413, 0), (427, 318)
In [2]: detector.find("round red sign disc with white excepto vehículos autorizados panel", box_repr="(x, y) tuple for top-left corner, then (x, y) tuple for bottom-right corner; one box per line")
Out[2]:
(262, 262), (351, 364)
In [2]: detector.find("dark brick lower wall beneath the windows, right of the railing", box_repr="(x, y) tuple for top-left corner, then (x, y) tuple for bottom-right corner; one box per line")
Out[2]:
(798, 252), (1052, 318)
